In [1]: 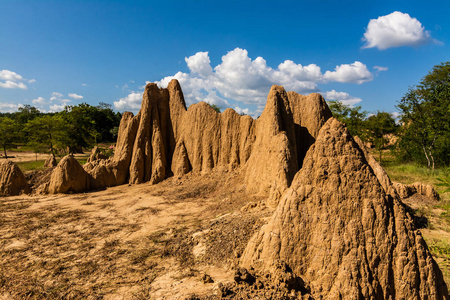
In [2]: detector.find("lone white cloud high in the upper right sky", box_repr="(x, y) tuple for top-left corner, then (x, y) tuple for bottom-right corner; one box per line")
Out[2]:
(363, 11), (433, 50)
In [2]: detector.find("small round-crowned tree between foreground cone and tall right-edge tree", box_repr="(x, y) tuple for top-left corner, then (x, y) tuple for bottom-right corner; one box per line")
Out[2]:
(365, 111), (398, 162)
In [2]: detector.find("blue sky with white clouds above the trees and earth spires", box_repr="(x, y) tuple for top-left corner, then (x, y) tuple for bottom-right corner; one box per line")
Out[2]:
(0, 0), (450, 116)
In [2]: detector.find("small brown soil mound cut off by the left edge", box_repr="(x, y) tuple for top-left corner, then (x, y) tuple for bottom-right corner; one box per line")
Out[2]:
(0, 160), (30, 196)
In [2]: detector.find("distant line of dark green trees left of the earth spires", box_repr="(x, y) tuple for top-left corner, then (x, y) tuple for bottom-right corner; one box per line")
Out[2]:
(0, 102), (122, 156)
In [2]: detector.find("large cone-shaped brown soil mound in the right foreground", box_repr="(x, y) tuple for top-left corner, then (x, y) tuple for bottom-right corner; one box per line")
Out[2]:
(241, 119), (448, 299)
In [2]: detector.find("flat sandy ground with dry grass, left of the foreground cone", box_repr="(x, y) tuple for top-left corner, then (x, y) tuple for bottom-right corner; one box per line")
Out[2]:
(0, 168), (271, 299)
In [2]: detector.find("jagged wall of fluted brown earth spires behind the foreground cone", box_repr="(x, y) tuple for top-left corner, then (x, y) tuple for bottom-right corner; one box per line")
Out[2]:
(42, 80), (331, 204)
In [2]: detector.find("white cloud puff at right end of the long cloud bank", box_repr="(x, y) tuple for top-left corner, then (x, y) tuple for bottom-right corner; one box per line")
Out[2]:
(324, 61), (373, 84)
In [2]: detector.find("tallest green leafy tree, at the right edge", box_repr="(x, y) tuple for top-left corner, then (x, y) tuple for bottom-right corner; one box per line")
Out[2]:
(397, 62), (450, 169)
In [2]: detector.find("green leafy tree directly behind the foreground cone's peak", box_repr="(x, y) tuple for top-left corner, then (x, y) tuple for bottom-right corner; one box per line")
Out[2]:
(328, 101), (367, 140)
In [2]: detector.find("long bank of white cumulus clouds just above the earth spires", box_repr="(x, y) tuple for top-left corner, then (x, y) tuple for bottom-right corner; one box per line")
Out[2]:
(114, 48), (373, 115)
